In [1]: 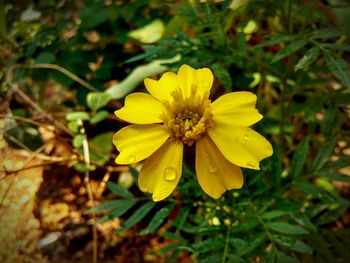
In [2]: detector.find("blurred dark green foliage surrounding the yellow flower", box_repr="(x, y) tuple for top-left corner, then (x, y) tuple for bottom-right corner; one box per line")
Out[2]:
(0, 0), (350, 263)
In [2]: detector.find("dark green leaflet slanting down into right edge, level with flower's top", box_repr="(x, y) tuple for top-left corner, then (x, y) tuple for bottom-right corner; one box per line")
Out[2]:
(325, 52), (350, 88)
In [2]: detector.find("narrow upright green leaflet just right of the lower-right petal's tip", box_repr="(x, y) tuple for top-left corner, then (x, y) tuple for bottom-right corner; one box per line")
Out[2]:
(290, 136), (310, 177)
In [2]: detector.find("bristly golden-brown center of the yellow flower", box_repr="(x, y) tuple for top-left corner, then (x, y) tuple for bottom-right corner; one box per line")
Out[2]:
(164, 90), (212, 146)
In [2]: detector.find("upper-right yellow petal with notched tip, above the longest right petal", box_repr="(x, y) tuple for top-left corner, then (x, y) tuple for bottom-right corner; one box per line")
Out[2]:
(211, 91), (262, 126)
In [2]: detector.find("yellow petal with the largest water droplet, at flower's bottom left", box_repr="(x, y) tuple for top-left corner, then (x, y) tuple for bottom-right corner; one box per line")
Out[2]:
(138, 140), (183, 202)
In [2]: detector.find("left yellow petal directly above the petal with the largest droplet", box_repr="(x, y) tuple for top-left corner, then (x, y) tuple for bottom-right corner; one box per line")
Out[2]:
(113, 124), (169, 164)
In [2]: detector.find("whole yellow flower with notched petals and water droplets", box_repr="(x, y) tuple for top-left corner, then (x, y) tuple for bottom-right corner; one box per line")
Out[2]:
(113, 65), (272, 201)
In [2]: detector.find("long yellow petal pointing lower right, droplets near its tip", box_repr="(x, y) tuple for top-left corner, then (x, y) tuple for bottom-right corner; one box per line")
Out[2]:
(208, 122), (272, 170)
